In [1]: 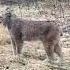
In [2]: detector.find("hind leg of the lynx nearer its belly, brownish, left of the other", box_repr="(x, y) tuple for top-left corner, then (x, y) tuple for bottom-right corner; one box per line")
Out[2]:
(43, 41), (54, 63)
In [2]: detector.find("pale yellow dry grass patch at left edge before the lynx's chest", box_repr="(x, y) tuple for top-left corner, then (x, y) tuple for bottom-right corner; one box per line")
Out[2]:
(0, 24), (10, 45)
